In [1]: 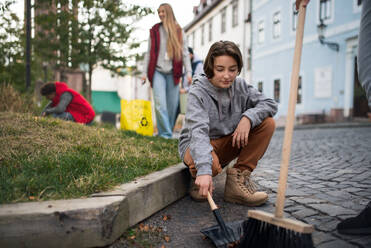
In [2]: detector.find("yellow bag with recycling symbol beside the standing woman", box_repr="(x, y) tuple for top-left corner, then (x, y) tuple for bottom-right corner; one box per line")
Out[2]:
(120, 99), (153, 136)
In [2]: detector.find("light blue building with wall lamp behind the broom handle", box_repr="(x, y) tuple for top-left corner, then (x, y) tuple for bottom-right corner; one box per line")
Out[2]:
(252, 0), (371, 123)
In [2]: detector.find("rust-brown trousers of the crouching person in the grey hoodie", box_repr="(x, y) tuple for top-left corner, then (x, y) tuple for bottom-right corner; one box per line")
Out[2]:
(184, 117), (275, 178)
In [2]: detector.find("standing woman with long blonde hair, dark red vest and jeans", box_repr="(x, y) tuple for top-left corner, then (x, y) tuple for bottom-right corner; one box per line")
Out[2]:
(142, 3), (192, 138)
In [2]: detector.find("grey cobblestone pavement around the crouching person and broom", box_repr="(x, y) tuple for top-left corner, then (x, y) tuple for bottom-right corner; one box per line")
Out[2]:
(112, 126), (371, 248)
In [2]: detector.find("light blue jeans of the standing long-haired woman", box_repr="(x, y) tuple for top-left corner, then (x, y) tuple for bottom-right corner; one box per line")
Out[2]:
(153, 70), (179, 138)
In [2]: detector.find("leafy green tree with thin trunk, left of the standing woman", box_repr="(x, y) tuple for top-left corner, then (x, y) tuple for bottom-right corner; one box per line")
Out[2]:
(34, 0), (152, 100)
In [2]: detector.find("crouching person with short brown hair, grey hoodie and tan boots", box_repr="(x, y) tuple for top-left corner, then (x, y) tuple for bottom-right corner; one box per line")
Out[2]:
(179, 41), (277, 206)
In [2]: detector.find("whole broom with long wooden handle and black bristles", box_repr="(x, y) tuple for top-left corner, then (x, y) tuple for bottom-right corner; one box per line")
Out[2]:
(240, 4), (314, 248)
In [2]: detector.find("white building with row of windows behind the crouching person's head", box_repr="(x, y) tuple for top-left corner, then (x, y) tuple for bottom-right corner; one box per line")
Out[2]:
(184, 0), (251, 81)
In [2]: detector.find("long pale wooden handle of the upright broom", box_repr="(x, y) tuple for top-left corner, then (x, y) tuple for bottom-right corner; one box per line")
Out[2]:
(275, 4), (306, 218)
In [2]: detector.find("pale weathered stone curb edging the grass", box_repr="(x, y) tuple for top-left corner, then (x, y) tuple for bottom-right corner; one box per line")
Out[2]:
(0, 163), (189, 247)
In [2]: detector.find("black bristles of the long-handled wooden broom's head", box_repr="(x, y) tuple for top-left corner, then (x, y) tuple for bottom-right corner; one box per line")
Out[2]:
(239, 218), (314, 248)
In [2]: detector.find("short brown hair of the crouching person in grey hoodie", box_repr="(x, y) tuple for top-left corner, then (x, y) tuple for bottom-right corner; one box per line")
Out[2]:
(204, 40), (243, 78)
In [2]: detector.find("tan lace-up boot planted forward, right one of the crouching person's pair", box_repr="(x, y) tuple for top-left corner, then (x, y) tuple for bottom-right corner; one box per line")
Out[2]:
(224, 168), (268, 207)
